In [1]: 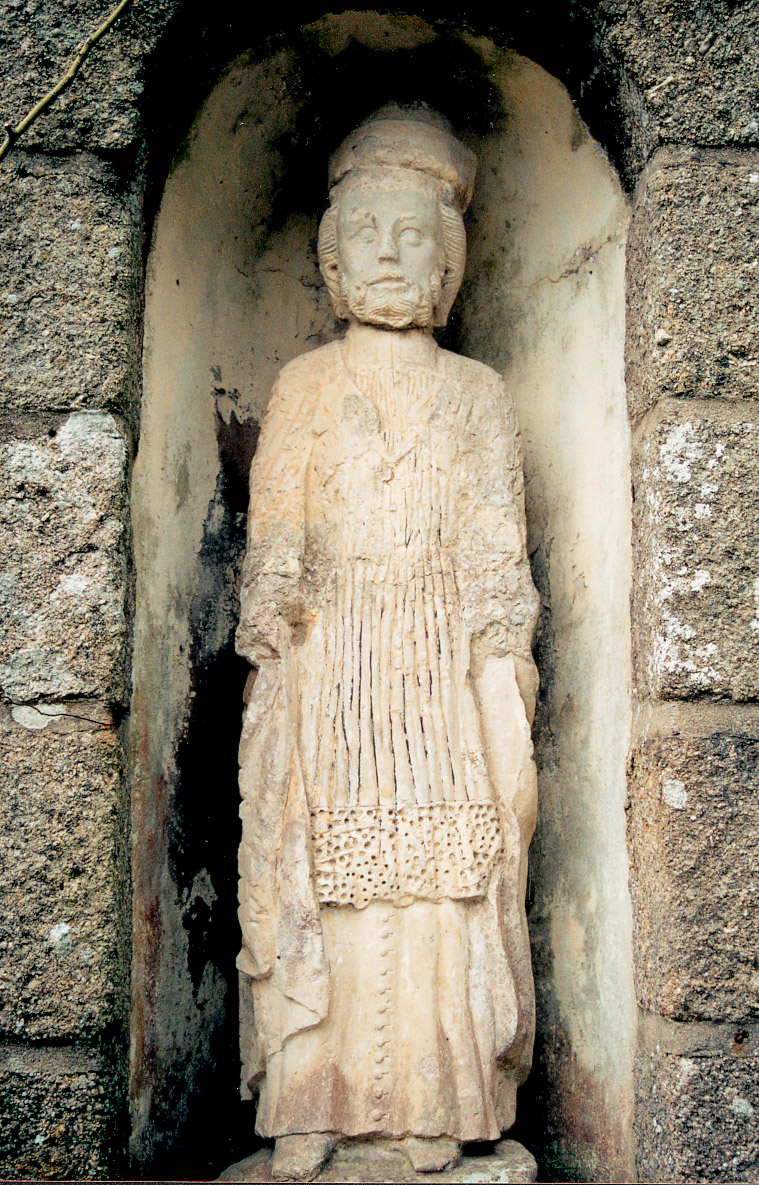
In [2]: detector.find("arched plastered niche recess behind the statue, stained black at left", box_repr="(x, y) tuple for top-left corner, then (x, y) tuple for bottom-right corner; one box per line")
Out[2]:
(131, 13), (636, 1179)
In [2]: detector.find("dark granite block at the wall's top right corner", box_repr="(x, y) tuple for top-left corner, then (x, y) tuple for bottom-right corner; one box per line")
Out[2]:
(592, 0), (759, 174)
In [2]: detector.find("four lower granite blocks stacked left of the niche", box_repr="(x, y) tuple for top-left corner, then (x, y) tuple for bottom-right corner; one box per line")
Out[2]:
(0, 152), (141, 1177)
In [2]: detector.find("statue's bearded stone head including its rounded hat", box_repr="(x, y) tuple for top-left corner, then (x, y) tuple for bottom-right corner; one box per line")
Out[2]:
(319, 104), (476, 329)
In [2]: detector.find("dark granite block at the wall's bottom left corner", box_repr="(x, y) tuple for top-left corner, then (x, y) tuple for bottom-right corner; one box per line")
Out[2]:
(0, 1044), (123, 1180)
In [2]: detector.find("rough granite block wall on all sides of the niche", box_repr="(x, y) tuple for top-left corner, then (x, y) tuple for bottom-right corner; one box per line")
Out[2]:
(0, 0), (759, 1181)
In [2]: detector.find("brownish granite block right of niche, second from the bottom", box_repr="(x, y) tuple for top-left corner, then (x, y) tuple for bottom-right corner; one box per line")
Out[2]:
(629, 732), (759, 1021)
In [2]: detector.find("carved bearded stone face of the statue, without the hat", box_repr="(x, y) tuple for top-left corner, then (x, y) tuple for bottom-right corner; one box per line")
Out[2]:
(336, 181), (445, 329)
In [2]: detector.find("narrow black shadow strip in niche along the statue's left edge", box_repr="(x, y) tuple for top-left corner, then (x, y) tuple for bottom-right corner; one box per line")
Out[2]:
(152, 417), (258, 1180)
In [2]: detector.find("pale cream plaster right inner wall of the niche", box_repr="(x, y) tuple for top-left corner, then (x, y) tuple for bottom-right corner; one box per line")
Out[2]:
(455, 46), (637, 1180)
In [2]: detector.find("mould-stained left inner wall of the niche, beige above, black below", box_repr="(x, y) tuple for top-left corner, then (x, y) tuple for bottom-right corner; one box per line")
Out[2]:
(129, 53), (312, 1165)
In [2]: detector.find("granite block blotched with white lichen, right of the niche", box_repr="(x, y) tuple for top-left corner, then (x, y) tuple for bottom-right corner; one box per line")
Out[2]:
(633, 402), (759, 700)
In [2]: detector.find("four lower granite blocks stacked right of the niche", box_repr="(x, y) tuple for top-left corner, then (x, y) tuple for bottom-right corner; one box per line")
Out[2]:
(628, 136), (759, 1181)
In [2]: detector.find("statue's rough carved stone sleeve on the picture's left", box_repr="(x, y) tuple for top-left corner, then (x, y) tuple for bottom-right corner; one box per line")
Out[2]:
(237, 372), (313, 664)
